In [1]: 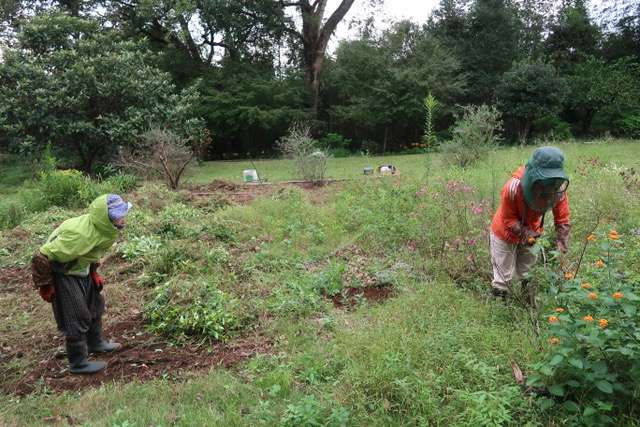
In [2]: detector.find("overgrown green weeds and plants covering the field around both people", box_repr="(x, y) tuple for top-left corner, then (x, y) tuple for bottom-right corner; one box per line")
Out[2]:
(0, 143), (640, 426)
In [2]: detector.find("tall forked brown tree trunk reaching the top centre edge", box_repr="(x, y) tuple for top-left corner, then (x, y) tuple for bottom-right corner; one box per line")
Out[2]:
(296, 0), (355, 118)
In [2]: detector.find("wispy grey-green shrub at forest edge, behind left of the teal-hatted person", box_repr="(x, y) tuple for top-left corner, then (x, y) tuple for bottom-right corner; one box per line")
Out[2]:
(441, 105), (502, 168)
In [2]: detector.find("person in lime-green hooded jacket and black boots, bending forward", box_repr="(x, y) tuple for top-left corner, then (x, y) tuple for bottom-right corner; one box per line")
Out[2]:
(31, 194), (131, 374)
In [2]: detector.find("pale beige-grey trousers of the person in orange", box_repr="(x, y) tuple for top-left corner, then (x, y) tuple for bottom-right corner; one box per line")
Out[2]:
(489, 233), (538, 291)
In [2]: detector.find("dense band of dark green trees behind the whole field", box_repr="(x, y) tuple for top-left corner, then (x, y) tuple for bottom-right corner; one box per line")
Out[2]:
(0, 0), (640, 172)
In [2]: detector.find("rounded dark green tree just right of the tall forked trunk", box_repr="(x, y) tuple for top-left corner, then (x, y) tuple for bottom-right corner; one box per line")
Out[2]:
(326, 21), (464, 151)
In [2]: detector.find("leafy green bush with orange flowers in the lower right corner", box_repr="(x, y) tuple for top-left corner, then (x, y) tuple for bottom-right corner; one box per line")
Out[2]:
(528, 230), (640, 426)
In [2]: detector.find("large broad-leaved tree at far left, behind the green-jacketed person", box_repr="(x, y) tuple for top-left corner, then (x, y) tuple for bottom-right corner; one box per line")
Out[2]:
(0, 14), (205, 172)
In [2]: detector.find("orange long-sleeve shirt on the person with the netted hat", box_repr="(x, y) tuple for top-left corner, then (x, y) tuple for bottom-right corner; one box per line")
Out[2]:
(491, 166), (571, 243)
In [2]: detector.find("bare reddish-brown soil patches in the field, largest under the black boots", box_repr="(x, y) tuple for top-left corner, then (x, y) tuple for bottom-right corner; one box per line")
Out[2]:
(0, 181), (392, 396)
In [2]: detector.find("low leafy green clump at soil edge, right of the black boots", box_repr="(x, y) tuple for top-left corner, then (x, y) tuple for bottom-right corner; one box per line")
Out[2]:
(145, 281), (240, 340)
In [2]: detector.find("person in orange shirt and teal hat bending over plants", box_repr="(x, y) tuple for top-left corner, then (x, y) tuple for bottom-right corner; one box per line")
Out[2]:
(490, 147), (571, 297)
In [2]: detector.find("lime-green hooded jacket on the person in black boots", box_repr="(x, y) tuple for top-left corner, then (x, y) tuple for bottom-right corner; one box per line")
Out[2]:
(40, 194), (119, 275)
